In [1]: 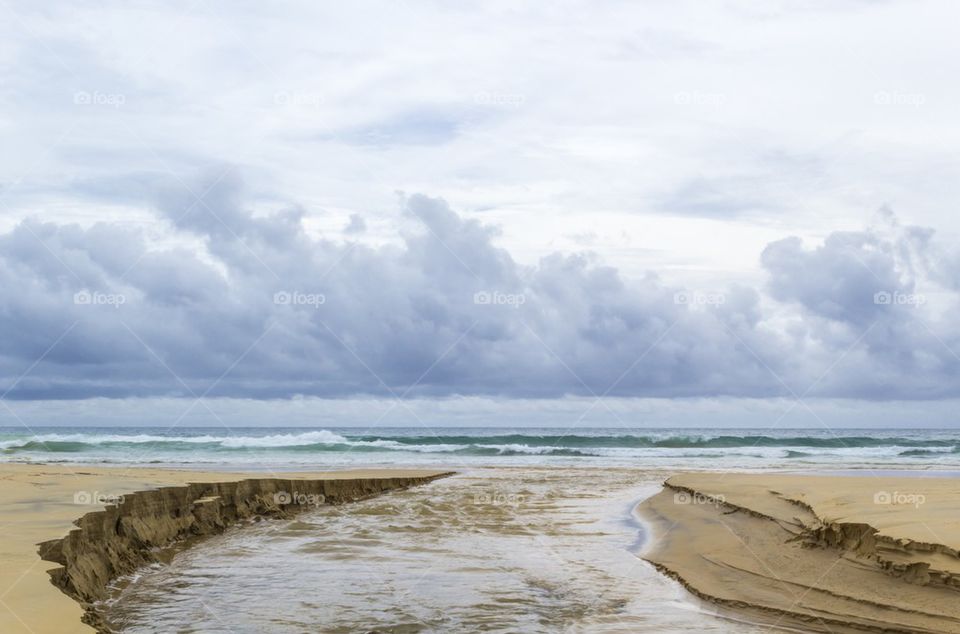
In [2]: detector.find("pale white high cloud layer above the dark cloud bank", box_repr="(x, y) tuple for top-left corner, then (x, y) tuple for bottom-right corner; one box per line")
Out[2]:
(0, 0), (960, 281)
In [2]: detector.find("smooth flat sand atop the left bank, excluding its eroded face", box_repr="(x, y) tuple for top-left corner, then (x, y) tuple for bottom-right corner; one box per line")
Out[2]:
(0, 464), (450, 634)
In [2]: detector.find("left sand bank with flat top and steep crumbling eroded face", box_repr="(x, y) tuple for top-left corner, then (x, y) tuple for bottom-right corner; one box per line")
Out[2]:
(0, 465), (444, 634)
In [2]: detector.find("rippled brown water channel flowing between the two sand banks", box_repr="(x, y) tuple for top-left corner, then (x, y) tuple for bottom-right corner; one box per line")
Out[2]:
(106, 468), (761, 633)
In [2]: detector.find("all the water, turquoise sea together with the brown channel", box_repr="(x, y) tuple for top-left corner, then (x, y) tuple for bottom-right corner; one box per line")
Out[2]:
(15, 427), (960, 634)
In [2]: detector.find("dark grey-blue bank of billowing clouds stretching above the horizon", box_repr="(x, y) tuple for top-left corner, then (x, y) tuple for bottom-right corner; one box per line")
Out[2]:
(0, 177), (960, 399)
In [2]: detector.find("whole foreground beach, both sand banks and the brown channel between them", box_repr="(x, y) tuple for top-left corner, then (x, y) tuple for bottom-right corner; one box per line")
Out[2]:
(0, 456), (960, 634)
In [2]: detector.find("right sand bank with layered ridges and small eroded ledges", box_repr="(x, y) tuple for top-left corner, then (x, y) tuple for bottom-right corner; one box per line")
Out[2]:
(640, 473), (960, 632)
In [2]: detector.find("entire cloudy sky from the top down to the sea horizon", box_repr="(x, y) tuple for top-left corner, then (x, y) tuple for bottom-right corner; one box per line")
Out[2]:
(0, 0), (960, 427)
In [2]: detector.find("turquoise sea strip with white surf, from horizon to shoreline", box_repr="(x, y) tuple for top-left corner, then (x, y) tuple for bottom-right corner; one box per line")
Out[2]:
(0, 427), (960, 470)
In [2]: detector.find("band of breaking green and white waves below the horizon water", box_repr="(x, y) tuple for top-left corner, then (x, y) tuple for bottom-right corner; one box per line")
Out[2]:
(0, 429), (960, 461)
